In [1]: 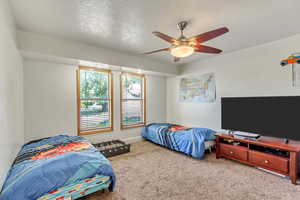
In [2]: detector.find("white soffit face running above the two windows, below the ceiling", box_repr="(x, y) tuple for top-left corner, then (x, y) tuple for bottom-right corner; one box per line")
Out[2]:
(17, 31), (177, 75)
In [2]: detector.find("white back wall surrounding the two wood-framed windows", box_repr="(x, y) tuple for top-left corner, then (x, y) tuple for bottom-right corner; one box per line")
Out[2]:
(24, 59), (166, 142)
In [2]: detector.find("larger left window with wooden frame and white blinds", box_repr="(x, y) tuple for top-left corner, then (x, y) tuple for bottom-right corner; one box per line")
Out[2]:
(77, 66), (113, 135)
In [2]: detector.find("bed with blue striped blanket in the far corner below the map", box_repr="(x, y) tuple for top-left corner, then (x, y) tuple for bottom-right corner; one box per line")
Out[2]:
(142, 123), (216, 159)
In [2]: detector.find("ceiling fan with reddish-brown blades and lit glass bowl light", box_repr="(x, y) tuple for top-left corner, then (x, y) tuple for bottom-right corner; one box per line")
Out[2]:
(144, 21), (229, 62)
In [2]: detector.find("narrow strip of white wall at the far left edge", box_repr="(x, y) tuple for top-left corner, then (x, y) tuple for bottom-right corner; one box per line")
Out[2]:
(0, 0), (24, 188)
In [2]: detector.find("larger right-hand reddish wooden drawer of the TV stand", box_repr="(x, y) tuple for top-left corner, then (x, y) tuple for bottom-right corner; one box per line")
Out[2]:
(249, 151), (289, 174)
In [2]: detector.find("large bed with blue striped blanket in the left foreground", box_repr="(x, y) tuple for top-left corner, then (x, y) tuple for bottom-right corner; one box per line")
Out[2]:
(0, 135), (115, 200)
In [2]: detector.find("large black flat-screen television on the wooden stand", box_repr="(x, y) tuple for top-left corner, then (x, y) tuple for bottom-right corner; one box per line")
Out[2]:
(221, 96), (300, 140)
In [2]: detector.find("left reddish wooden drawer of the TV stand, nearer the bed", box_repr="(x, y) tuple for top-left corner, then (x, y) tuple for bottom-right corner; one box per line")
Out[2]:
(220, 144), (248, 161)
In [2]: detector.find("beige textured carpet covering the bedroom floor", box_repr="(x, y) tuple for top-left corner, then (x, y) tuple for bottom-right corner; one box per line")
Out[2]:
(83, 141), (300, 200)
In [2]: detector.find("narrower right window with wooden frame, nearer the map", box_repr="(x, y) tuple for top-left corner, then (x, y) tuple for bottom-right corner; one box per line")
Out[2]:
(121, 73), (146, 129)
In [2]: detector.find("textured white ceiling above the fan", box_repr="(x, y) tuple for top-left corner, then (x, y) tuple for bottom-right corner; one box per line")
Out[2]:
(11, 0), (300, 64)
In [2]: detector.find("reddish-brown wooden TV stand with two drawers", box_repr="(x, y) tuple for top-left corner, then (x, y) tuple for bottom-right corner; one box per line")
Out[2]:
(216, 134), (300, 184)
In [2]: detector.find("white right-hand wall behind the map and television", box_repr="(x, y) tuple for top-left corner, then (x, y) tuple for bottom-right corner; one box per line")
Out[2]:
(167, 35), (300, 130)
